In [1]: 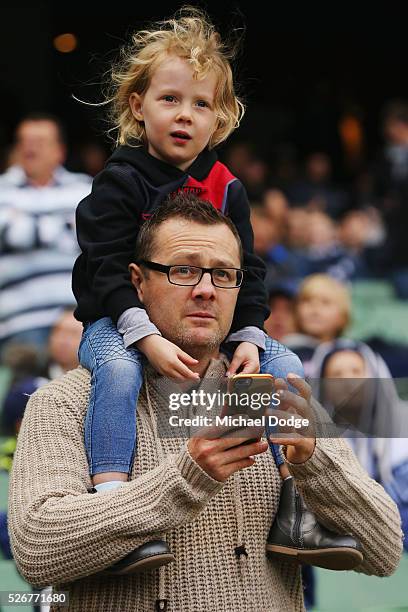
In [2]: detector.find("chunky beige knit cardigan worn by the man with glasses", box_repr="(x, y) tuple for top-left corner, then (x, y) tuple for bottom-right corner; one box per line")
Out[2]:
(9, 360), (402, 612)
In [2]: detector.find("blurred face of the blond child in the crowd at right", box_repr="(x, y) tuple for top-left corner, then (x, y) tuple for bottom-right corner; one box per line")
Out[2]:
(297, 287), (344, 342)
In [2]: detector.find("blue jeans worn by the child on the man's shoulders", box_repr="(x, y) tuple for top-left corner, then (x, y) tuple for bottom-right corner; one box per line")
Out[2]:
(79, 317), (303, 476)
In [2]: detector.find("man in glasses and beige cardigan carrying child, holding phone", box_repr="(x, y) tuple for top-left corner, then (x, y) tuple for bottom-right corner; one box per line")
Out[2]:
(9, 199), (401, 612)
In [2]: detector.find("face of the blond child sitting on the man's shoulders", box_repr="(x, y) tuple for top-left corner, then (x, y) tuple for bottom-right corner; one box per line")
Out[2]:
(129, 55), (217, 170)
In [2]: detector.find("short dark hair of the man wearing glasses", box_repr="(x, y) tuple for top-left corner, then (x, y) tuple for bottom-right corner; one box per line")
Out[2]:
(135, 193), (244, 265)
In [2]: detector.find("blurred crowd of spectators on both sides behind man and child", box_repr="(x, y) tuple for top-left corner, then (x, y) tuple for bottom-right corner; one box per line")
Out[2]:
(0, 101), (408, 608)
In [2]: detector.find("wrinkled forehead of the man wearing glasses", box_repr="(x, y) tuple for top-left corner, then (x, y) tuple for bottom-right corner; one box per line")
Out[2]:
(155, 218), (240, 267)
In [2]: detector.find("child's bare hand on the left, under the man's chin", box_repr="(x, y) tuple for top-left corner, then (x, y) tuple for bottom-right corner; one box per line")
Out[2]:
(136, 334), (200, 380)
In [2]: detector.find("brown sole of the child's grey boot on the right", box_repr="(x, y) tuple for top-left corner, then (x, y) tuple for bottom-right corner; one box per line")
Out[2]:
(266, 544), (363, 571)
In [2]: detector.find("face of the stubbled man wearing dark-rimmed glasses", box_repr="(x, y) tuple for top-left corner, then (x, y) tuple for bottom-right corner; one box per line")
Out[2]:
(130, 218), (241, 358)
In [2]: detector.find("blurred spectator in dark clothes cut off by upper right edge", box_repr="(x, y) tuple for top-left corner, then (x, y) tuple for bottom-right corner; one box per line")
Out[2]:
(373, 100), (408, 299)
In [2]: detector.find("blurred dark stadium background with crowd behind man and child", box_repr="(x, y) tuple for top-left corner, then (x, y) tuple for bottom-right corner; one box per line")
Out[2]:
(0, 1), (408, 611)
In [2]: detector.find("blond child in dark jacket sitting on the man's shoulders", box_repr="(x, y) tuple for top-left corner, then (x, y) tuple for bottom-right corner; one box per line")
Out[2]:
(73, 9), (358, 573)
